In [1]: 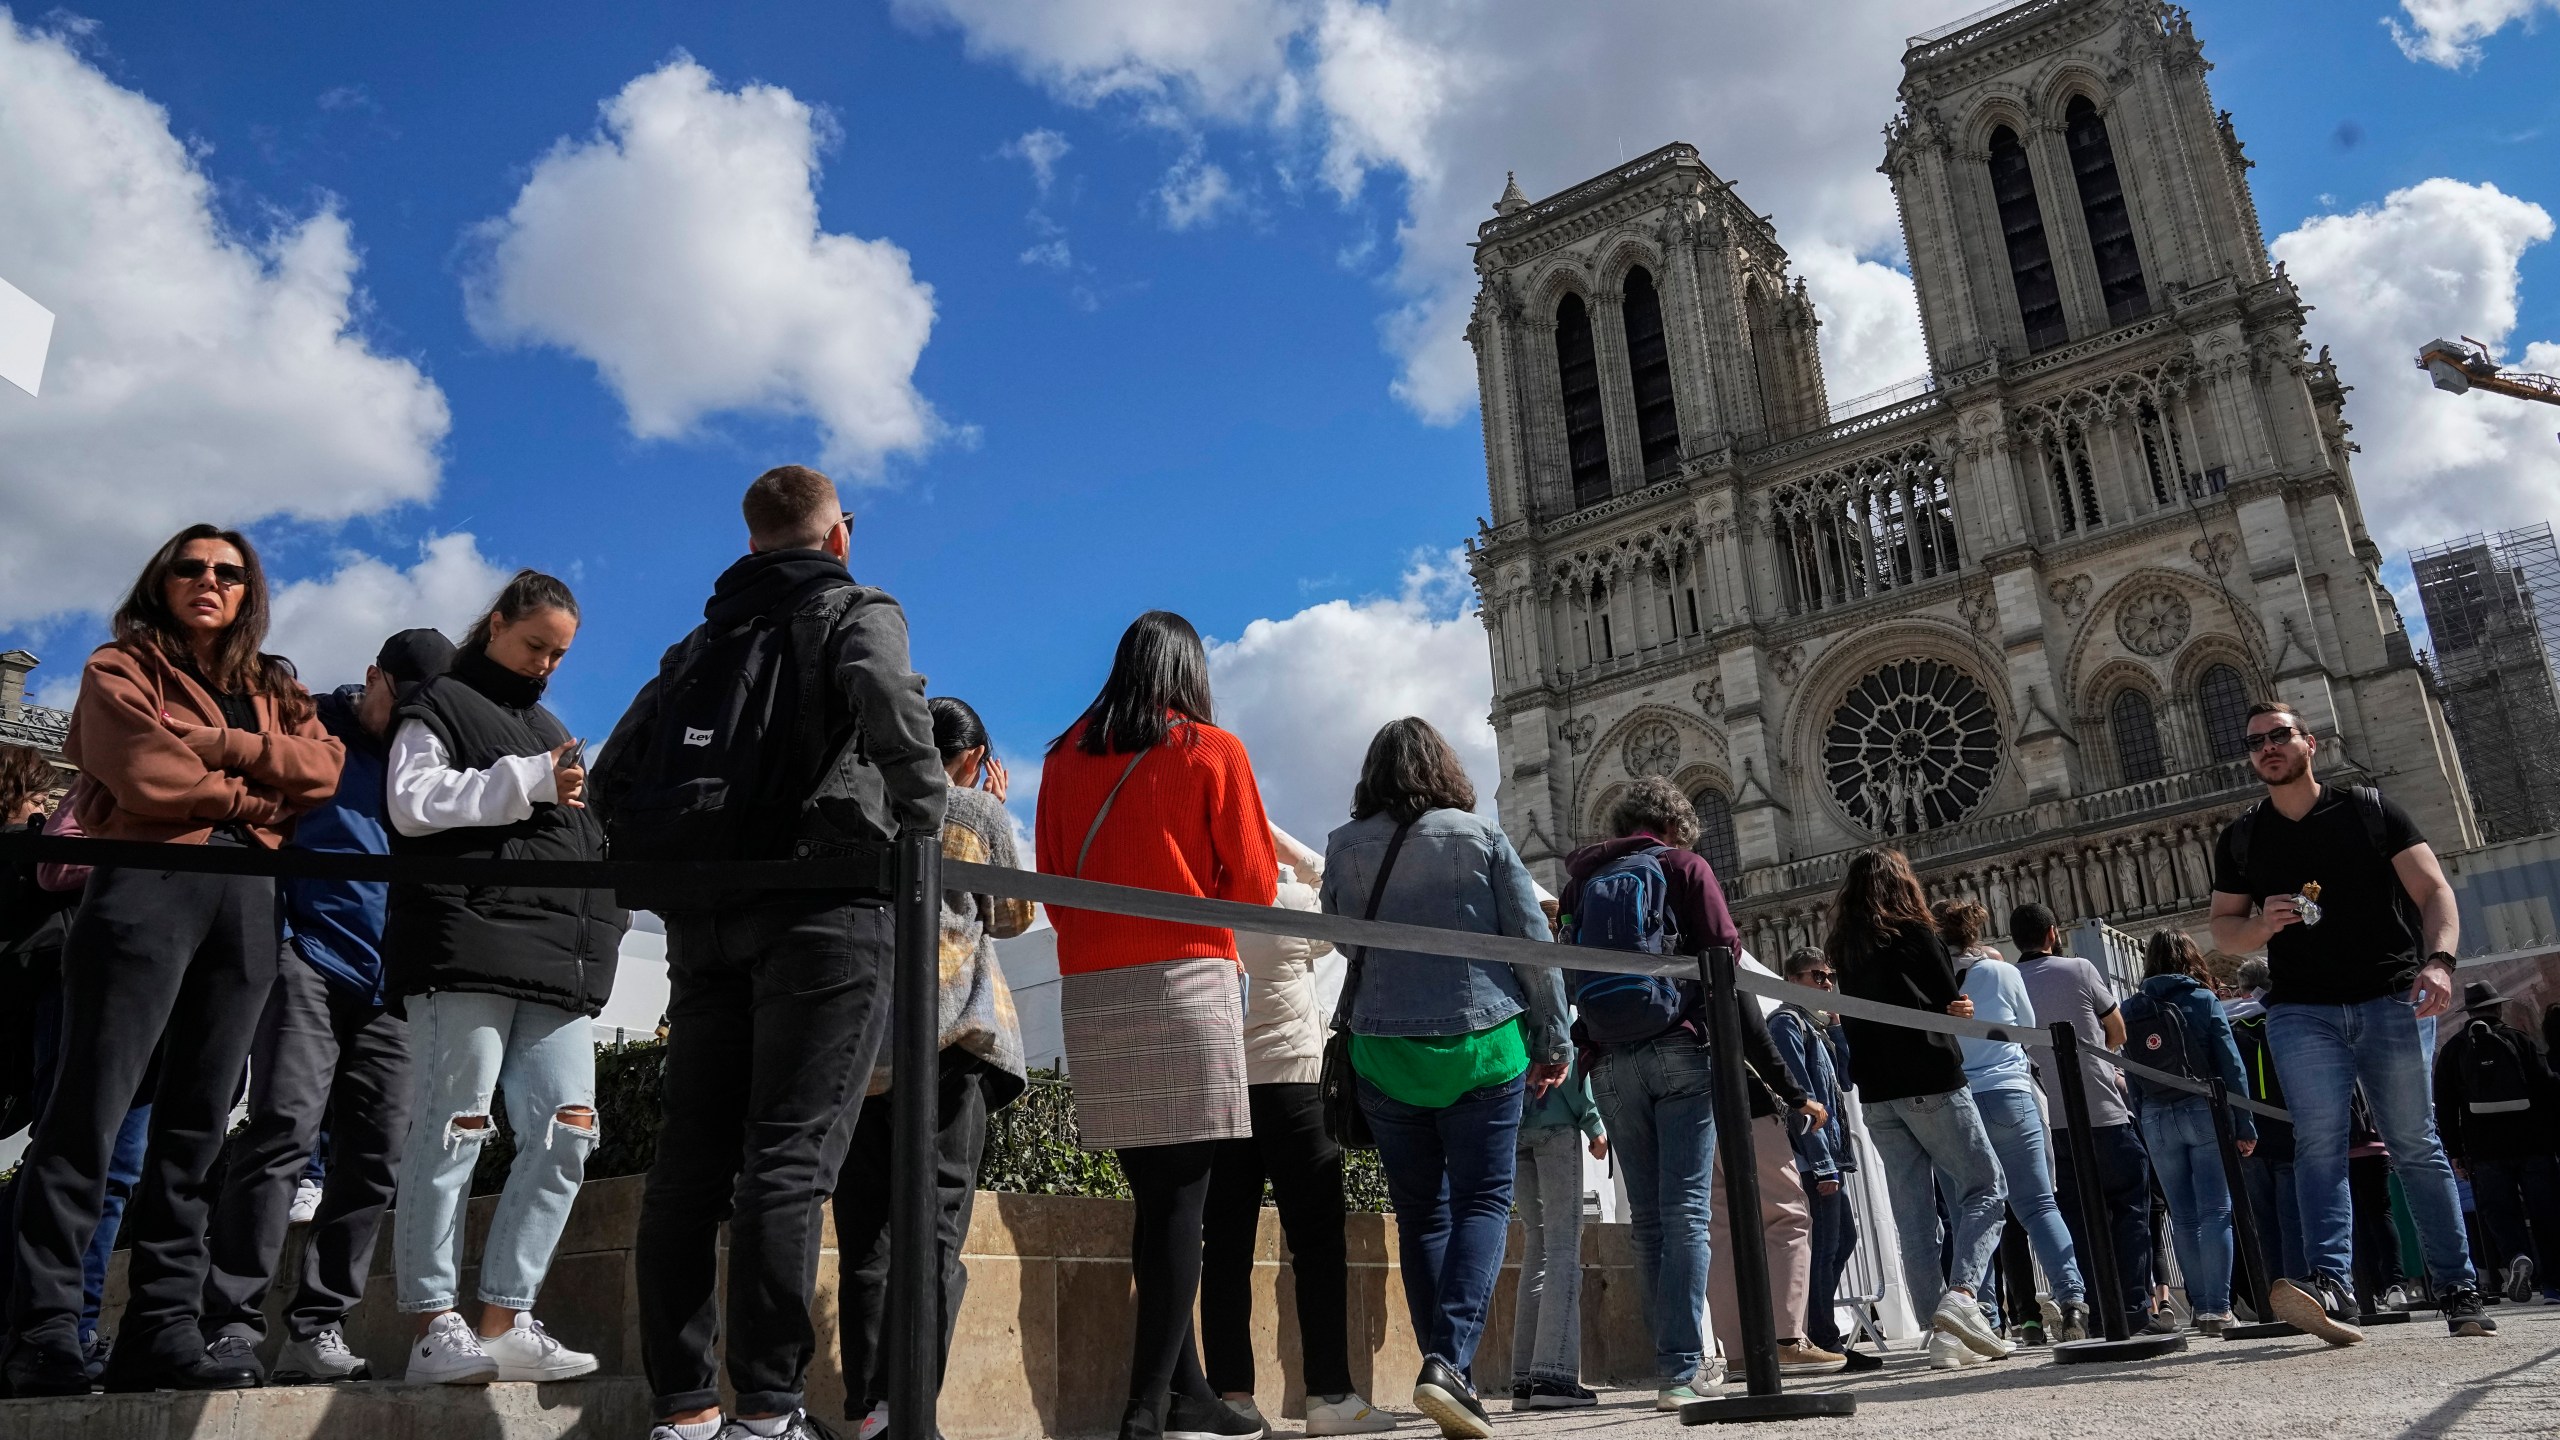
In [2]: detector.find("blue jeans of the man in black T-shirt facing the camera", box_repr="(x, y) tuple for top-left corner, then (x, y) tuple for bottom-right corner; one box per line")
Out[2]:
(2266, 994), (2478, 1291)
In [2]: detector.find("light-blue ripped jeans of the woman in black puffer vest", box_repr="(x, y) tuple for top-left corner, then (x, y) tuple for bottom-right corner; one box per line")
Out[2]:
(394, 992), (599, 1314)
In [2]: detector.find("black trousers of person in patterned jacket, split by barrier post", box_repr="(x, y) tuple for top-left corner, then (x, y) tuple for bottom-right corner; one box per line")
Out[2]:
(835, 1045), (1001, 1420)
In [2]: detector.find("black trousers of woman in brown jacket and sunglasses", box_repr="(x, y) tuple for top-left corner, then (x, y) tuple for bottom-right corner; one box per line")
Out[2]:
(10, 869), (276, 1368)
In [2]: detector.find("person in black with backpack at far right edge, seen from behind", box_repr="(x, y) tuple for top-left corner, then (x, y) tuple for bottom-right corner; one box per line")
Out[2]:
(2435, 981), (2560, 1304)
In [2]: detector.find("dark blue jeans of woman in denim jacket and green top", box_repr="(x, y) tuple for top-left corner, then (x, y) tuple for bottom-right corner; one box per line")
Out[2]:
(1359, 1076), (1528, 1384)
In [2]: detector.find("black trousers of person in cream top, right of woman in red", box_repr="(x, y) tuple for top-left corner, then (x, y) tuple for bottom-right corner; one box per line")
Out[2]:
(1201, 1084), (1352, 1394)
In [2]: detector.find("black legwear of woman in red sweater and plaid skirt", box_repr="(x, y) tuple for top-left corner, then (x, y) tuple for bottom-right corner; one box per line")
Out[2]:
(1119, 1140), (1219, 1435)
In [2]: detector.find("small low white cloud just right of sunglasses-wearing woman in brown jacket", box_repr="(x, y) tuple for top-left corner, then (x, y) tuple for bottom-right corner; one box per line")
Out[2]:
(266, 533), (509, 692)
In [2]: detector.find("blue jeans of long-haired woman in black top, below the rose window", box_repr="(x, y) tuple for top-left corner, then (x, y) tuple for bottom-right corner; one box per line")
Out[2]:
(1866, 1089), (2007, 1314)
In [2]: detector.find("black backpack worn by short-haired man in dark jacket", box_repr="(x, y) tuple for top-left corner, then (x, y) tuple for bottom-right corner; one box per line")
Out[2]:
(599, 584), (860, 910)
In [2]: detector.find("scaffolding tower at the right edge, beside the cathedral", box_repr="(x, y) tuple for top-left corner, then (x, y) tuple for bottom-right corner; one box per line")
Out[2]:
(2409, 525), (2560, 840)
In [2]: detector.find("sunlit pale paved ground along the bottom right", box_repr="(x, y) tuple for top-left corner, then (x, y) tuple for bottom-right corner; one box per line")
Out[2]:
(1484, 1304), (2560, 1440)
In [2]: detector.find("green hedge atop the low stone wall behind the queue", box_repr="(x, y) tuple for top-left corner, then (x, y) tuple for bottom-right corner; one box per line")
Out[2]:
(471, 1040), (1388, 1212)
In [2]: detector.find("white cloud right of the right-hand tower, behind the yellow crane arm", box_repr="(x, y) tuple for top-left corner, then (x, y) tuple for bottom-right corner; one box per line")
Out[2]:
(2273, 179), (2560, 551)
